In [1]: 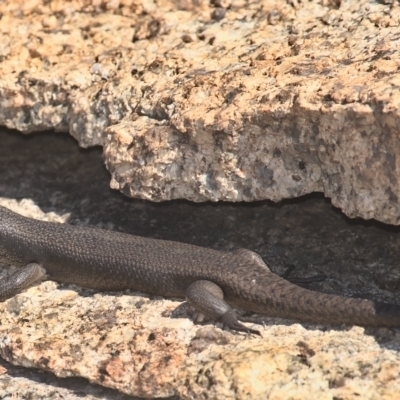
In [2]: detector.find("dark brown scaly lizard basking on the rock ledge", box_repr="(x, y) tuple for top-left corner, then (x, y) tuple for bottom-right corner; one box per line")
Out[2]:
(0, 206), (400, 334)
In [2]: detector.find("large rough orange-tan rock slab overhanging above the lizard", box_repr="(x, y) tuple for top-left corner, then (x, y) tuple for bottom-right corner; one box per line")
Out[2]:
(0, 0), (400, 224)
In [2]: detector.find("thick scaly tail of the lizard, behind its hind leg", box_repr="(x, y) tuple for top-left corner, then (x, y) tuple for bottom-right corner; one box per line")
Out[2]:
(227, 249), (400, 327)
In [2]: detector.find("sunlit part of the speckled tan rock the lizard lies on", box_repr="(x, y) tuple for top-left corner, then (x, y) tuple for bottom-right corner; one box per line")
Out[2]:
(0, 199), (400, 400)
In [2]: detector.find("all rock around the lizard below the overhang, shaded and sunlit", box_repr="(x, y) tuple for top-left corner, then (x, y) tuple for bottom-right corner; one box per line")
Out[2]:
(0, 129), (400, 400)
